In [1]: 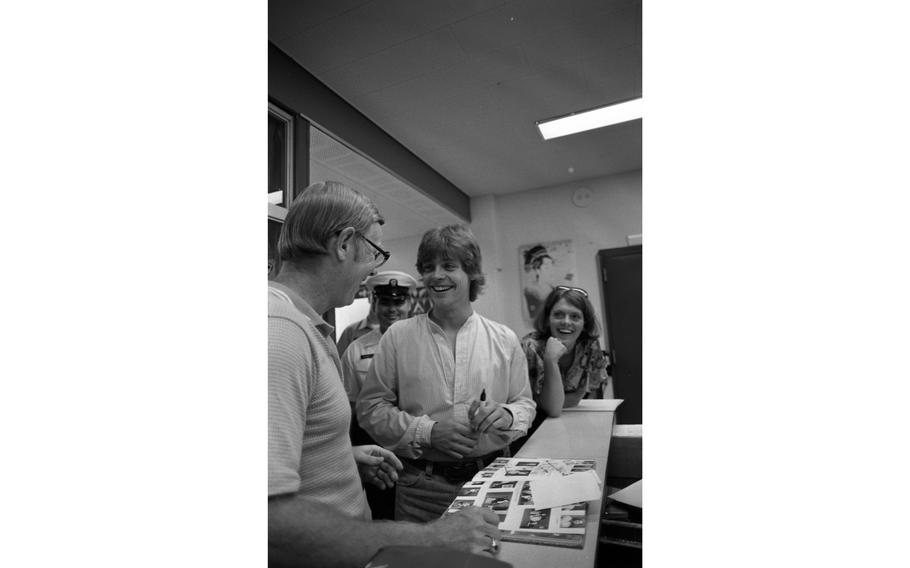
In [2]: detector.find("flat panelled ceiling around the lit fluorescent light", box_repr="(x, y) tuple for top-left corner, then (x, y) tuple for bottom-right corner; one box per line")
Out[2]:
(270, 0), (641, 200)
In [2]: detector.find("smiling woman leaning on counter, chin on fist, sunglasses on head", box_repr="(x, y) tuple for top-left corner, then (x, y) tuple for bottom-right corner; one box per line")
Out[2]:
(521, 286), (613, 446)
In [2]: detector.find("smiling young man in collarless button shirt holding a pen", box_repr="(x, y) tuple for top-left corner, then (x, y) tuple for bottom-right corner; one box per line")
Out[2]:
(356, 225), (535, 522)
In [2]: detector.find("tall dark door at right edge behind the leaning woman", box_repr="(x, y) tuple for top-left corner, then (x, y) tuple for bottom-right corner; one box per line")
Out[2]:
(597, 246), (642, 424)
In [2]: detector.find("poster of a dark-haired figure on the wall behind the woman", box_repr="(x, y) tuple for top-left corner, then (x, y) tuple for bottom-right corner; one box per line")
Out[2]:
(518, 239), (577, 329)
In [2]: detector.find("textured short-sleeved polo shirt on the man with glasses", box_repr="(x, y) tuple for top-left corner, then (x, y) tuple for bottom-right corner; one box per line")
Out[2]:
(268, 282), (371, 520)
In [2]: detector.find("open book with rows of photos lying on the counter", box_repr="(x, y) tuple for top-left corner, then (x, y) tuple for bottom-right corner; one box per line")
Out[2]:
(446, 458), (596, 548)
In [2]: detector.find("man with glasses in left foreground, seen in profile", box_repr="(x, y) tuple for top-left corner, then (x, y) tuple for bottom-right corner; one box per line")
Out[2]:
(268, 182), (502, 566)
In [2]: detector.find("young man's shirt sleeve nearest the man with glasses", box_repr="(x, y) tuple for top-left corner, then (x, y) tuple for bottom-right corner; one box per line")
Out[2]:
(356, 333), (436, 458)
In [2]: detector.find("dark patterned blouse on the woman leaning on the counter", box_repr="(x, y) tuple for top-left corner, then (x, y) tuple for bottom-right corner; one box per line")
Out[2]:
(521, 331), (608, 408)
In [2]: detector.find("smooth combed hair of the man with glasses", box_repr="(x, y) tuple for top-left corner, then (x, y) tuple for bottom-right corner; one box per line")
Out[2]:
(278, 181), (385, 262)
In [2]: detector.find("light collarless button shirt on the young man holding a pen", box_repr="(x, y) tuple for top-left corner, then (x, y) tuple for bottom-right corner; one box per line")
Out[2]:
(357, 313), (535, 461)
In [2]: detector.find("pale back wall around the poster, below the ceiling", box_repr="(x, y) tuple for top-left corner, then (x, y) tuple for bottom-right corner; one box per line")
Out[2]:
(384, 171), (643, 336)
